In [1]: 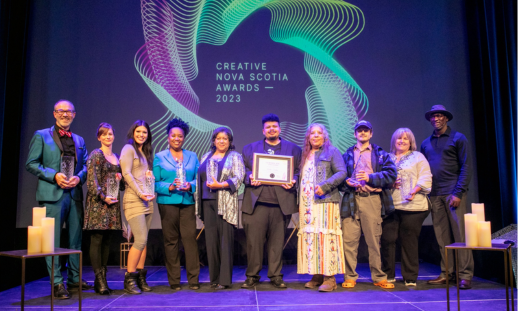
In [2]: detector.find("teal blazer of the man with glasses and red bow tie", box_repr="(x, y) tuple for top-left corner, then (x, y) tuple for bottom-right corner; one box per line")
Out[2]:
(25, 126), (88, 202)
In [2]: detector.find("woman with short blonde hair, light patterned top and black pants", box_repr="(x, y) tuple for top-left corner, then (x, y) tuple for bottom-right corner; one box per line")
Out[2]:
(381, 128), (432, 286)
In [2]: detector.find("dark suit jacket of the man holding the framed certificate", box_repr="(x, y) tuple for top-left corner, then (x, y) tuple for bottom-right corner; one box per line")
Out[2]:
(241, 139), (302, 215)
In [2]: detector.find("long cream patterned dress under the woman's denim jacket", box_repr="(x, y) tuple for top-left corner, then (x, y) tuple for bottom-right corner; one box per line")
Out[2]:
(297, 160), (345, 276)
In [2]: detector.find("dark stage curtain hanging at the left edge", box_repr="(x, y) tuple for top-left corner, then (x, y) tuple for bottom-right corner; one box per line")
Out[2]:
(0, 0), (33, 291)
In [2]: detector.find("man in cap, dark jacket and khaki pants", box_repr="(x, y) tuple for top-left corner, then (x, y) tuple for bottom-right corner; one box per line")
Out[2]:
(340, 120), (397, 288)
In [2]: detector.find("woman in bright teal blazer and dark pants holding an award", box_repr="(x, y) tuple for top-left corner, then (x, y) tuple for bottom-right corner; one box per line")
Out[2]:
(153, 118), (200, 290)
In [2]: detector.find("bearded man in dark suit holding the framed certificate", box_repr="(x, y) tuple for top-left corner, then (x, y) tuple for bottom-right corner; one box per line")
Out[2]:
(241, 114), (302, 288)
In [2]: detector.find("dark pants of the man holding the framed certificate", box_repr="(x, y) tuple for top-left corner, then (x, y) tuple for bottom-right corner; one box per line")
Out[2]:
(241, 202), (288, 279)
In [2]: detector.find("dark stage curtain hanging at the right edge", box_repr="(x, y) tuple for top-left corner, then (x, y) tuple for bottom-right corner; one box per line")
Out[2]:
(465, 0), (518, 232)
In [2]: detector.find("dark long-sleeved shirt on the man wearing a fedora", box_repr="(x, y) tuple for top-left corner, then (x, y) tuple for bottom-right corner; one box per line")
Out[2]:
(421, 126), (472, 198)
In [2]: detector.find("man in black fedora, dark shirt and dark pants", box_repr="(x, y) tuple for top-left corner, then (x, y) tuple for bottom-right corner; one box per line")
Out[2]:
(421, 105), (474, 289)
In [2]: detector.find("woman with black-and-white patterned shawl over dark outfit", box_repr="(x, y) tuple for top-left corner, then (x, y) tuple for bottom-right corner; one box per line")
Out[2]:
(196, 127), (245, 289)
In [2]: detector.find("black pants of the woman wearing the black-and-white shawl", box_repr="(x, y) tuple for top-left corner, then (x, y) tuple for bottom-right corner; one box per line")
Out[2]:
(202, 200), (234, 286)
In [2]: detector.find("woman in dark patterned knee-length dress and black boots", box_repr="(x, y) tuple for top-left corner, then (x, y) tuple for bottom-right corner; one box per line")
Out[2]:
(83, 123), (124, 295)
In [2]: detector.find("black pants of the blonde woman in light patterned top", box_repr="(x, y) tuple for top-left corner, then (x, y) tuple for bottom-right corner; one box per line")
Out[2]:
(381, 210), (430, 282)
